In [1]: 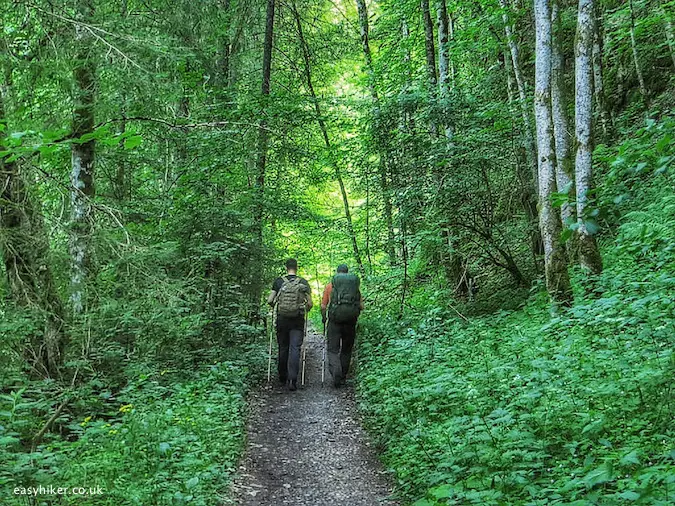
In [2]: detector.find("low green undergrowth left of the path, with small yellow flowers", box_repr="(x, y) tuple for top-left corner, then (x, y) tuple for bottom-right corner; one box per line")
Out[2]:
(0, 353), (259, 506)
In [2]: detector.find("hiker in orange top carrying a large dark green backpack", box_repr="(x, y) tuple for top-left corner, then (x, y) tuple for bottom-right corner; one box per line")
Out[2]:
(321, 264), (363, 388)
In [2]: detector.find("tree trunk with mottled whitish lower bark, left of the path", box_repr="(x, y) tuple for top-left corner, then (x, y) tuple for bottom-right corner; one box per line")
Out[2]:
(70, 0), (96, 315)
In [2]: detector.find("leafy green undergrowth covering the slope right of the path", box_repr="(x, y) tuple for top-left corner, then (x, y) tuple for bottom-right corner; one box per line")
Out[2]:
(358, 112), (675, 506)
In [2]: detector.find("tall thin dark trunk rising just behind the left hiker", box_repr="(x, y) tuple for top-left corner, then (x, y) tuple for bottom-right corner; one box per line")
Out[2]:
(253, 0), (275, 312)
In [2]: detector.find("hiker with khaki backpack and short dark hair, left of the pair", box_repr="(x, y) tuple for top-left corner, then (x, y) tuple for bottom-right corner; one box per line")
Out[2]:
(267, 258), (312, 390)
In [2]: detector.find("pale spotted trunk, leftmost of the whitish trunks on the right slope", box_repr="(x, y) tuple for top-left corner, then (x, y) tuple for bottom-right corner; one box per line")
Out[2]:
(534, 0), (572, 304)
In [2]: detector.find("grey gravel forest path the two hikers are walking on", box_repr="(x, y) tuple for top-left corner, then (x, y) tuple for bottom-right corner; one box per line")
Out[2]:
(233, 327), (398, 506)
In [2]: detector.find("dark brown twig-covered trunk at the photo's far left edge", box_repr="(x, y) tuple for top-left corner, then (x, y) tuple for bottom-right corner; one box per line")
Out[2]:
(0, 69), (67, 378)
